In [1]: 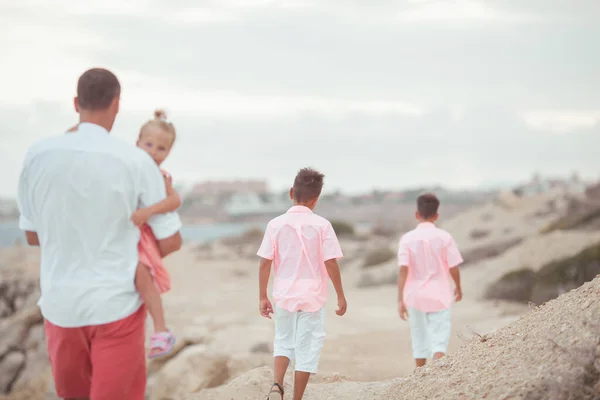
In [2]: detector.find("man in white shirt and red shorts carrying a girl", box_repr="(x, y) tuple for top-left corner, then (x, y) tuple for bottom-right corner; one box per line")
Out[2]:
(18, 68), (181, 400)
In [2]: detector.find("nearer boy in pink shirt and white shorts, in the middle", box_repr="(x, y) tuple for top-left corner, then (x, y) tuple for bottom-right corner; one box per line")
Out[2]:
(258, 168), (347, 400)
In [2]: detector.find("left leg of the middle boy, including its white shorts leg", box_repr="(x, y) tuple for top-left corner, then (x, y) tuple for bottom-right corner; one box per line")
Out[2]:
(273, 306), (297, 391)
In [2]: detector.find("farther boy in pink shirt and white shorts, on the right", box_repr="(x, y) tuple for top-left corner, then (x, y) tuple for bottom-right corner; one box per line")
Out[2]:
(398, 193), (463, 367)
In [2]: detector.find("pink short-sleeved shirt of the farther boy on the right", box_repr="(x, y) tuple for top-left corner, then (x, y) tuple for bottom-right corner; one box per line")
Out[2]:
(398, 222), (463, 312)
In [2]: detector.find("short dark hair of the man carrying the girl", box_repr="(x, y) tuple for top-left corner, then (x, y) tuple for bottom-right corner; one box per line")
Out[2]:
(77, 68), (121, 111)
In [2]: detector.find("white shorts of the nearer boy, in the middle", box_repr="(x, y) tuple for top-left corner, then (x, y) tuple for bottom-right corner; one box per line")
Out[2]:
(273, 307), (326, 374)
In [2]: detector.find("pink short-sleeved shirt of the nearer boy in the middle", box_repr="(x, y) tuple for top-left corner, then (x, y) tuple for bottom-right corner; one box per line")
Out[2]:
(257, 206), (343, 312)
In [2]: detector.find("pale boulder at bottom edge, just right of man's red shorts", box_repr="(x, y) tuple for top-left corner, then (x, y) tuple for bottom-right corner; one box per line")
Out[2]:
(149, 345), (229, 400)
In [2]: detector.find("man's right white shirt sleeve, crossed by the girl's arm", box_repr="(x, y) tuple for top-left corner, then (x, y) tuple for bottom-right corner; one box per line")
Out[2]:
(139, 155), (181, 240)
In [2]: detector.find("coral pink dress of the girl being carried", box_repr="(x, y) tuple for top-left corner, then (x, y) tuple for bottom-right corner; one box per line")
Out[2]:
(138, 171), (171, 294)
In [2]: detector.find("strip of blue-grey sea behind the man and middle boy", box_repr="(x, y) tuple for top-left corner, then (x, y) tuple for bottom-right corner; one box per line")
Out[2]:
(0, 221), (265, 247)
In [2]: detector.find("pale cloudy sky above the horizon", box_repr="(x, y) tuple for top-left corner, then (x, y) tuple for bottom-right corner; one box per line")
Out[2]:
(0, 0), (600, 196)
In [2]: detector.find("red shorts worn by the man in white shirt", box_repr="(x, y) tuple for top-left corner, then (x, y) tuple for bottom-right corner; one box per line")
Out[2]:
(44, 306), (146, 400)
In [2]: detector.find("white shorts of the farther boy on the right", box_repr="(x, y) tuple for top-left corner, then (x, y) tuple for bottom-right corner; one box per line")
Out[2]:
(408, 308), (451, 359)
